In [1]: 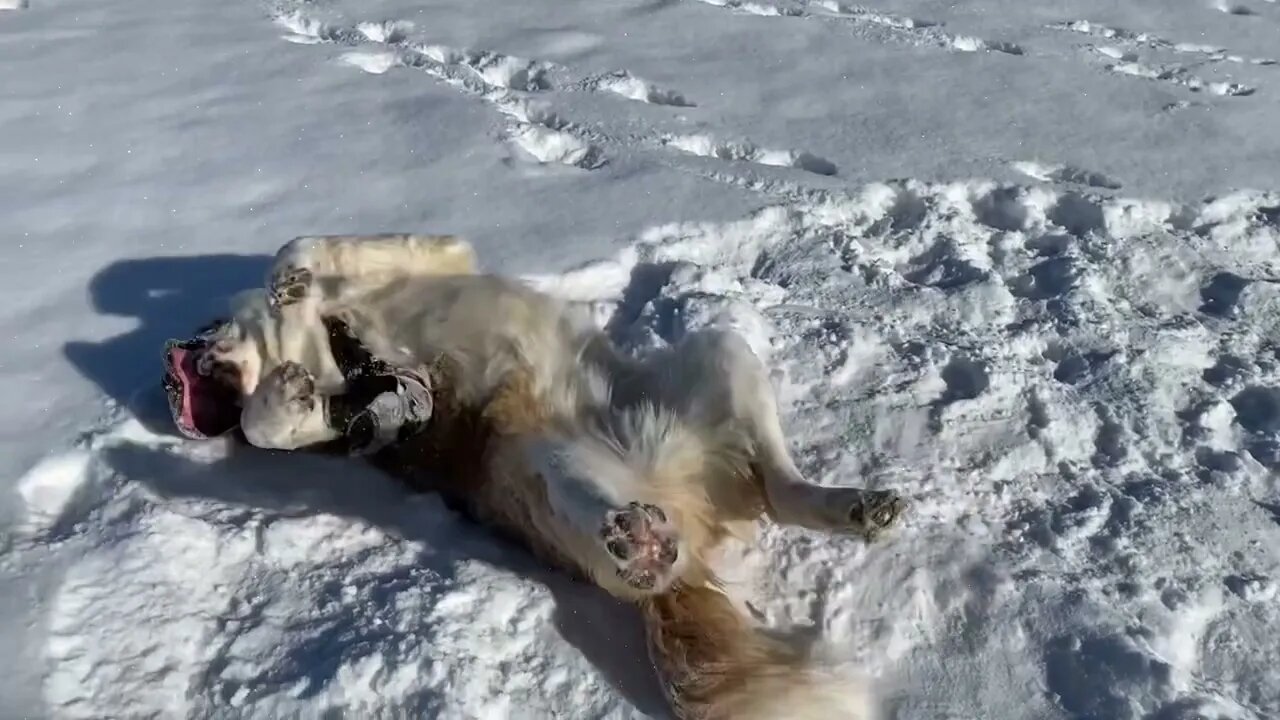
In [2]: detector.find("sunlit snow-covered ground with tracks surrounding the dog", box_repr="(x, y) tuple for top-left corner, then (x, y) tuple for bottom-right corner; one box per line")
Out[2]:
(0, 0), (1280, 720)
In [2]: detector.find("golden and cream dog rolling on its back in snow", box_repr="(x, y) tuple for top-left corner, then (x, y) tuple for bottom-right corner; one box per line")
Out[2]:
(165, 236), (905, 720)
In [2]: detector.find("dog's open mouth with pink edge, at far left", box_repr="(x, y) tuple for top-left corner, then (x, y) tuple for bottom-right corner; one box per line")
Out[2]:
(164, 337), (239, 439)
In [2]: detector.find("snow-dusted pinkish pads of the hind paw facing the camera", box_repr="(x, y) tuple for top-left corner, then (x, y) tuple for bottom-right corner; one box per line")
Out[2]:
(600, 502), (680, 592)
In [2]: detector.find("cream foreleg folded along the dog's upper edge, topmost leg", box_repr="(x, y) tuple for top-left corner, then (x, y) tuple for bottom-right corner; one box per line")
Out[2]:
(268, 229), (476, 307)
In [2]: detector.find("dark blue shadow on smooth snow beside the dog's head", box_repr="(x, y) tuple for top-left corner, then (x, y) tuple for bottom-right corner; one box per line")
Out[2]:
(63, 254), (271, 432)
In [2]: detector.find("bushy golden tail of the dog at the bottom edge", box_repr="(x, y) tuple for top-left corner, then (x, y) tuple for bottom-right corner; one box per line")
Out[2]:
(640, 585), (877, 720)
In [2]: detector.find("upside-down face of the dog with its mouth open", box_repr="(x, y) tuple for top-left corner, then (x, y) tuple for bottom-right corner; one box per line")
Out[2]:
(163, 313), (261, 439)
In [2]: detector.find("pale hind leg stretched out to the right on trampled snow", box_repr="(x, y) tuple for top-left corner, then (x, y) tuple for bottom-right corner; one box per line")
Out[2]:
(668, 331), (906, 539)
